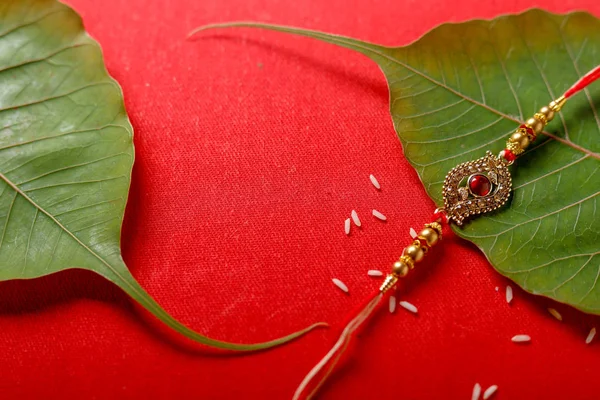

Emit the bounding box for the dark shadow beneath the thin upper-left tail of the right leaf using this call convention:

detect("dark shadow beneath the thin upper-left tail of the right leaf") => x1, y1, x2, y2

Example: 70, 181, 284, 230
193, 33, 389, 103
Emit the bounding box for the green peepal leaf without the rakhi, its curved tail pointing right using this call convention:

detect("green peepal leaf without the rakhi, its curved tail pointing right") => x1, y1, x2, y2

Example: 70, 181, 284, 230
0, 0, 326, 351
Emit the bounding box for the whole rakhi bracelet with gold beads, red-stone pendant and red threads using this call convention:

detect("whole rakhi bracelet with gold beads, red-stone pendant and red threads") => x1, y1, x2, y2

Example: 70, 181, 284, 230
294, 66, 600, 400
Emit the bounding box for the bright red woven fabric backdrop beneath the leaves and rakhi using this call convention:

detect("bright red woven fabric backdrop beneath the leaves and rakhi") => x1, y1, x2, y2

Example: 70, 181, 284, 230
0, 0, 600, 399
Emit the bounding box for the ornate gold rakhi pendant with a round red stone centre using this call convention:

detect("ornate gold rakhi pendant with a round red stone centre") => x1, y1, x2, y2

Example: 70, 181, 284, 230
443, 151, 512, 225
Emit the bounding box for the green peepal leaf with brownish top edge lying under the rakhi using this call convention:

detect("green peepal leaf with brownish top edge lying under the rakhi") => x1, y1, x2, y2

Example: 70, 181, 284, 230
192, 10, 600, 314
